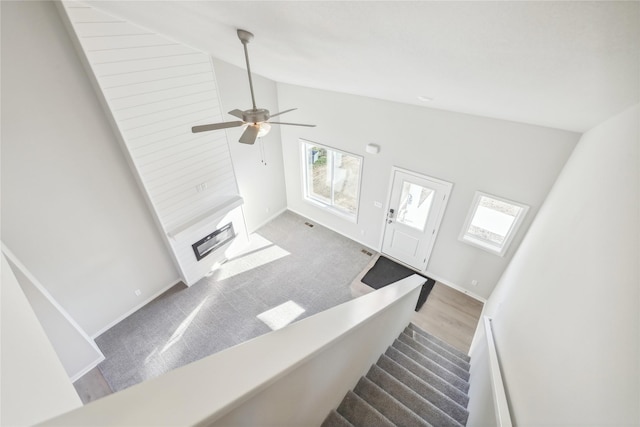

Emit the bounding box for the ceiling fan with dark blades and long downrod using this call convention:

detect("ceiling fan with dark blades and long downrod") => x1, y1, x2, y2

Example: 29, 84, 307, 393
191, 30, 315, 144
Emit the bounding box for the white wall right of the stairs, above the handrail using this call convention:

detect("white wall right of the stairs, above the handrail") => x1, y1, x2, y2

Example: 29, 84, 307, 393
470, 105, 640, 426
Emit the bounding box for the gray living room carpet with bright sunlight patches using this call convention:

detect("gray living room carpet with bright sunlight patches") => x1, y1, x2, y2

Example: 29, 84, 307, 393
96, 211, 373, 392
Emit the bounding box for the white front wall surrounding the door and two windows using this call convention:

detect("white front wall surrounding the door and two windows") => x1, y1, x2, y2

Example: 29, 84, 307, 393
278, 84, 579, 298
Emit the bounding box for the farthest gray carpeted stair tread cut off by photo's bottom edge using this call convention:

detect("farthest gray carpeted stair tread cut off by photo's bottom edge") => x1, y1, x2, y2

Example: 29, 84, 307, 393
366, 365, 460, 427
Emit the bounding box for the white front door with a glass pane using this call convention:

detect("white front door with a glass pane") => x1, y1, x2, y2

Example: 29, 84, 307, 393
382, 168, 453, 271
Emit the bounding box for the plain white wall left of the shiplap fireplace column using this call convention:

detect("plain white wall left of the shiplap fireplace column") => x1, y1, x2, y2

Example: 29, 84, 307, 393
1, 2, 178, 335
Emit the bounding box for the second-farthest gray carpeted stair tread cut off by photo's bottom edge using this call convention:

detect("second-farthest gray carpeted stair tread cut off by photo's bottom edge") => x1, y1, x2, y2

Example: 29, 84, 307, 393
353, 377, 430, 427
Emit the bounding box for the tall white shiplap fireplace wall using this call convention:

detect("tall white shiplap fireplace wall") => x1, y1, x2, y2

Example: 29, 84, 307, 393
63, 2, 246, 285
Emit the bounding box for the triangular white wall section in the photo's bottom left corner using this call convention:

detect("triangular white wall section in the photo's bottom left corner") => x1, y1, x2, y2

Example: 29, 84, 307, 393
0, 256, 82, 426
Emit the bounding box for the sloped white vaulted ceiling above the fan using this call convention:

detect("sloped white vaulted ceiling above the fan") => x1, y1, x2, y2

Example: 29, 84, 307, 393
86, 1, 640, 132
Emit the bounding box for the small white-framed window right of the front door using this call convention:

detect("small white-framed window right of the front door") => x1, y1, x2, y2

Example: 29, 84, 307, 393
460, 191, 529, 256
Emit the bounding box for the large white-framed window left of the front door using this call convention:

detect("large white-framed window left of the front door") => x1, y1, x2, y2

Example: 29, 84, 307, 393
300, 141, 362, 222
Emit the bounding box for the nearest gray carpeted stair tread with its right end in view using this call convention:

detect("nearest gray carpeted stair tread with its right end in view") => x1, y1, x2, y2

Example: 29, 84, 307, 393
376, 354, 469, 425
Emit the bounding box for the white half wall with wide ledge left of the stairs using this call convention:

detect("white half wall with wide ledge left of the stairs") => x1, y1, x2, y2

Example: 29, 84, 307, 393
42, 275, 425, 427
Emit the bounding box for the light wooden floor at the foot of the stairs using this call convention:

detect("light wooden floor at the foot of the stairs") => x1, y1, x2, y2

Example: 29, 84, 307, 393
411, 282, 483, 353
